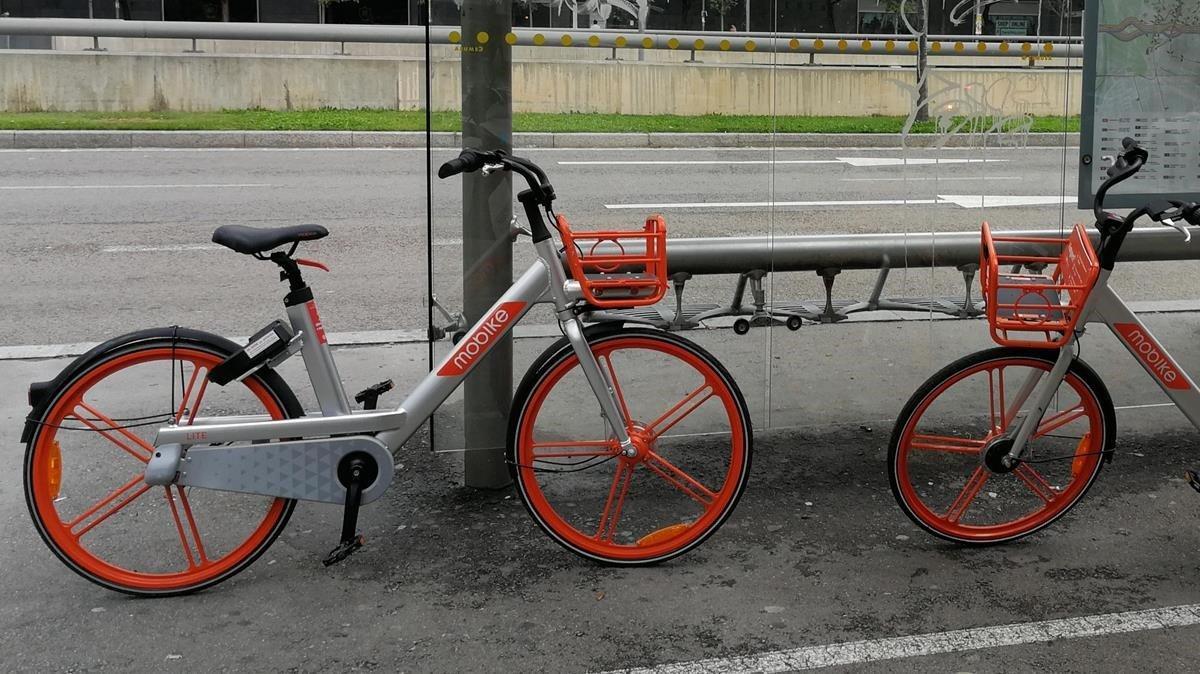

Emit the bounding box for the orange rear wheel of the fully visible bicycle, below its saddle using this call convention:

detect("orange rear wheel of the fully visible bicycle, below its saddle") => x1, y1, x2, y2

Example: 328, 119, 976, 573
25, 332, 301, 595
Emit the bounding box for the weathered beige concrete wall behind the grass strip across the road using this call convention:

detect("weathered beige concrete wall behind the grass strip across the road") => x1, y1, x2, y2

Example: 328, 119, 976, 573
0, 52, 1080, 115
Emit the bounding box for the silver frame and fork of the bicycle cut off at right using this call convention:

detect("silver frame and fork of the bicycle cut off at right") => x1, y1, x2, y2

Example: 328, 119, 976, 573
1006, 269, 1200, 459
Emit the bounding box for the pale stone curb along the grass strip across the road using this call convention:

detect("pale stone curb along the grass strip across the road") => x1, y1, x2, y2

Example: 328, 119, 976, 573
0, 131, 1079, 150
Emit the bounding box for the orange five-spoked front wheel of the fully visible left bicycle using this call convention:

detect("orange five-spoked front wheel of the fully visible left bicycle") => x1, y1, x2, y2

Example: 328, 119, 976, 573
509, 329, 751, 565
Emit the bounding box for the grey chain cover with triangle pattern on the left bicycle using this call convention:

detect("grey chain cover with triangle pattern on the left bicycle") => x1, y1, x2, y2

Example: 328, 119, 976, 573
145, 435, 395, 505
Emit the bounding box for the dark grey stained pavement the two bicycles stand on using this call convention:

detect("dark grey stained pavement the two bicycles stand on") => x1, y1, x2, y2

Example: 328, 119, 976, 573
0, 313, 1200, 672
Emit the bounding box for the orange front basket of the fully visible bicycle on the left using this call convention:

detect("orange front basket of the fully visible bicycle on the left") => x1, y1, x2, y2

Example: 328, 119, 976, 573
558, 216, 667, 308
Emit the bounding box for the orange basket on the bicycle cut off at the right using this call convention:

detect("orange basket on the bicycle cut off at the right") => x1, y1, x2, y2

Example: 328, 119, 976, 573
979, 222, 1100, 349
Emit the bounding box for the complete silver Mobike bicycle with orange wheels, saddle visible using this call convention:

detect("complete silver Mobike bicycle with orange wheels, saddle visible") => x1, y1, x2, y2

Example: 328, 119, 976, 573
22, 150, 752, 595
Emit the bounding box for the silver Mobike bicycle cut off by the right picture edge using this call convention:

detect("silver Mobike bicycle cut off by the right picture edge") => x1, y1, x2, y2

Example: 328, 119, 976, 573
888, 138, 1200, 543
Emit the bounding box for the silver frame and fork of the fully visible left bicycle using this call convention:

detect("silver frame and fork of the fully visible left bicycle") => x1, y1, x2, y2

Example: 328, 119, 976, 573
155, 233, 634, 453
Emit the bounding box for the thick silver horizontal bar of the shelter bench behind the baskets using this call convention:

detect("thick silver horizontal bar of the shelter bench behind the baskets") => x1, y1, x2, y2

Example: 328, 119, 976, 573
667, 228, 1200, 275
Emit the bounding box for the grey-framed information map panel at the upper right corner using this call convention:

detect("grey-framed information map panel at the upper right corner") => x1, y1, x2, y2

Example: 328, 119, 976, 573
1079, 0, 1200, 209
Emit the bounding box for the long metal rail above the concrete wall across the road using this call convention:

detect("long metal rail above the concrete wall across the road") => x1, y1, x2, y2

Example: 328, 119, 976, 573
0, 17, 1084, 58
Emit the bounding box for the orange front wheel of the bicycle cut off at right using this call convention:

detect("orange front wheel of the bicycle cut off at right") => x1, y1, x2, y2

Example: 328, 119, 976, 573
888, 348, 1116, 544
